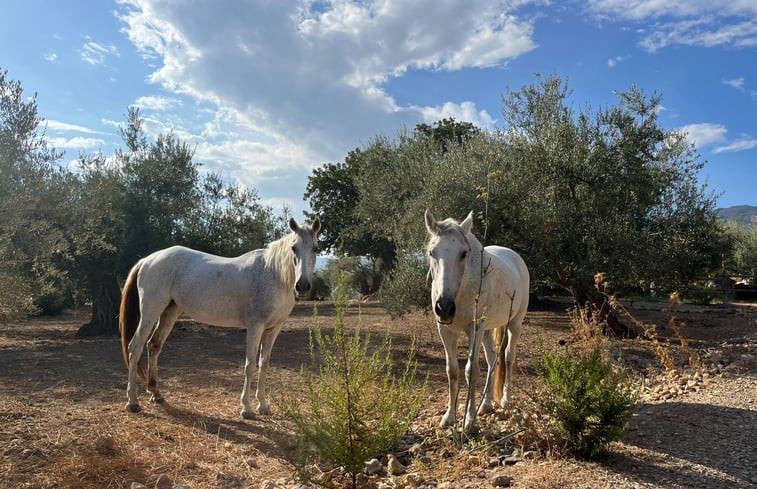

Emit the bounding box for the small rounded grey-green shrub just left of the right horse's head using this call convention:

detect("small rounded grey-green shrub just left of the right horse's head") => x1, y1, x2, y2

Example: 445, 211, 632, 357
381, 255, 430, 318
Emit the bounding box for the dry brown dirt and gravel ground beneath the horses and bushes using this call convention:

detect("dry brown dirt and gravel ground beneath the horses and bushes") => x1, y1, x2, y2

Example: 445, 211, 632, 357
0, 301, 757, 489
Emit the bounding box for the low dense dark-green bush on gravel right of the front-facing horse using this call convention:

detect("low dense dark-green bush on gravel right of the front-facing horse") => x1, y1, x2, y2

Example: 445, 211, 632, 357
536, 343, 634, 458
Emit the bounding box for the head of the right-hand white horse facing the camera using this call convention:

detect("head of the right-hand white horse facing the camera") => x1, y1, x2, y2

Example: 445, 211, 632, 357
425, 210, 473, 324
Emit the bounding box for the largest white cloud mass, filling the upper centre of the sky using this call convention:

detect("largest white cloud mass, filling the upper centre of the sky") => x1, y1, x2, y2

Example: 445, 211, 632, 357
121, 0, 542, 196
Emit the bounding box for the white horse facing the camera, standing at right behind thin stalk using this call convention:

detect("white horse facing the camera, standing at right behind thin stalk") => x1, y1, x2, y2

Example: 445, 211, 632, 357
425, 210, 530, 430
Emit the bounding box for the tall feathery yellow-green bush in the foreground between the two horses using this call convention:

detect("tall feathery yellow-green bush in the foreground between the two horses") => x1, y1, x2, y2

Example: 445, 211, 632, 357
281, 274, 425, 484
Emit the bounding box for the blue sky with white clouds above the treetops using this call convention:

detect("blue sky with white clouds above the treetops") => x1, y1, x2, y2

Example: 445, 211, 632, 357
0, 0, 757, 217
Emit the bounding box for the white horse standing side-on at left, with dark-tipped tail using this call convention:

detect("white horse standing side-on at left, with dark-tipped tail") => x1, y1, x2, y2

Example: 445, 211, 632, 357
119, 218, 321, 419
